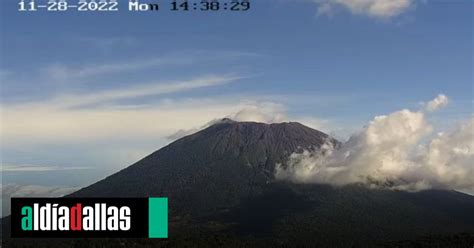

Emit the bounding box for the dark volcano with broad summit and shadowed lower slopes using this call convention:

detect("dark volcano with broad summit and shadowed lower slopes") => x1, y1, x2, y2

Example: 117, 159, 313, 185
3, 119, 474, 247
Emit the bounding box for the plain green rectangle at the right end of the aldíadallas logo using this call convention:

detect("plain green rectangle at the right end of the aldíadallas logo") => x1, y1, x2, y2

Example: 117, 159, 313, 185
148, 198, 168, 238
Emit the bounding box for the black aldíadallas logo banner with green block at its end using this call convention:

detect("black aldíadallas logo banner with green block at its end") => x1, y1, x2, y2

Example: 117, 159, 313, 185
11, 198, 168, 238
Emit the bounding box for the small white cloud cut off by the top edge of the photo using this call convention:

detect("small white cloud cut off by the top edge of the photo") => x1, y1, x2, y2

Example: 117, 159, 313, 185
314, 0, 415, 18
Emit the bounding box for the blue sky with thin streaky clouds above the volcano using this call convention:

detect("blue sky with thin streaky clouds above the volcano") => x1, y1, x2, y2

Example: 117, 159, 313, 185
0, 0, 474, 211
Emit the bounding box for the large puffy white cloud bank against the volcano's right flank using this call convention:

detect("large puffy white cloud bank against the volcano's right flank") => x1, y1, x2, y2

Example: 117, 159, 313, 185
276, 95, 474, 191
